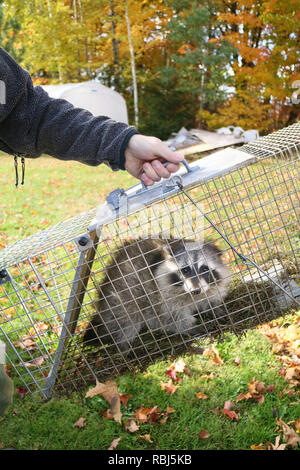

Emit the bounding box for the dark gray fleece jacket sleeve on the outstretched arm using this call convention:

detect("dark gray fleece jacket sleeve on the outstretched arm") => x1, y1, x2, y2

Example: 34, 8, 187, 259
0, 48, 138, 170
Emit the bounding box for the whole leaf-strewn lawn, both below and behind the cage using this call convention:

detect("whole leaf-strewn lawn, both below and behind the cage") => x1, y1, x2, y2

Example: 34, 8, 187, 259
0, 152, 300, 450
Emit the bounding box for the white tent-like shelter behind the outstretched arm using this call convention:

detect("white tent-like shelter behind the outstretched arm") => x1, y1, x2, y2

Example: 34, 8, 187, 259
43, 80, 128, 124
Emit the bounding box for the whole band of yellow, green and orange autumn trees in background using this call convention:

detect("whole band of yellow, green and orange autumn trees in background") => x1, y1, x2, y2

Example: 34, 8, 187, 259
0, 0, 300, 133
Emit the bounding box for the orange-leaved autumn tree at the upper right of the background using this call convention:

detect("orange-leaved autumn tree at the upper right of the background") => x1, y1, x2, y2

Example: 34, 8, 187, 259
202, 0, 300, 133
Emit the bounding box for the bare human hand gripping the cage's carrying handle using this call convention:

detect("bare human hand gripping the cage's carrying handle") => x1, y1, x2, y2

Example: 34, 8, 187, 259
125, 134, 184, 186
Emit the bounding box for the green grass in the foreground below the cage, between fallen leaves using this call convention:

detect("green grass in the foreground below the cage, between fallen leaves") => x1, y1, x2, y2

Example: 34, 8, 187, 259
0, 324, 300, 450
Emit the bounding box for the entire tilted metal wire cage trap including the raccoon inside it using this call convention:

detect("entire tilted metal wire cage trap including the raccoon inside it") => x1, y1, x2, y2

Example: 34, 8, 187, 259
0, 123, 300, 398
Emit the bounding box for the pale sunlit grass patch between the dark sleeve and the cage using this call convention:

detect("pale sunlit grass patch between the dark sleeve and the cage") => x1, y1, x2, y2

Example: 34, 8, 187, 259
0, 155, 137, 244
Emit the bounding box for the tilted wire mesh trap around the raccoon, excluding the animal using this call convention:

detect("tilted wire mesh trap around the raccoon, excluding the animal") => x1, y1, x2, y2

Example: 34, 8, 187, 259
0, 123, 300, 398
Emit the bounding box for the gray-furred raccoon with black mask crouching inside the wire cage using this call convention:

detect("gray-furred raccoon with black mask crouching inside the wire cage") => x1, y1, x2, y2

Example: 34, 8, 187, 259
83, 238, 230, 352
